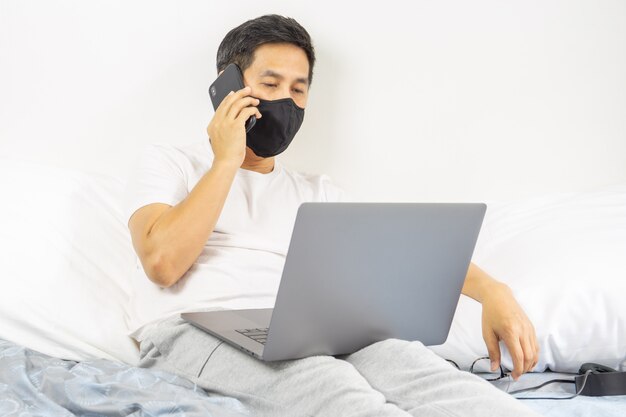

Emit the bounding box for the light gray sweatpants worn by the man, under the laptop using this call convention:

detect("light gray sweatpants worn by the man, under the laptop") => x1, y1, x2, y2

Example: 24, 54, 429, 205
139, 316, 538, 417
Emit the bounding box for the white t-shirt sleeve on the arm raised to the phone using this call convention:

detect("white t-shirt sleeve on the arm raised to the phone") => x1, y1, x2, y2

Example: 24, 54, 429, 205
124, 145, 189, 226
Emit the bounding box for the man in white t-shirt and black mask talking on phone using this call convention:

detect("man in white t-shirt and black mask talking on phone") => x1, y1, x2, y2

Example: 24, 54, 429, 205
128, 15, 538, 416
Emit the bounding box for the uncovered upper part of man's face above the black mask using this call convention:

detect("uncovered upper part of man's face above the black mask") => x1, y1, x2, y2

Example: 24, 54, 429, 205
243, 43, 309, 108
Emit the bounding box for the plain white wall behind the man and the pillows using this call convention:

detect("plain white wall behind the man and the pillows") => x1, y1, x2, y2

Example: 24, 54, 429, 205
0, 0, 626, 201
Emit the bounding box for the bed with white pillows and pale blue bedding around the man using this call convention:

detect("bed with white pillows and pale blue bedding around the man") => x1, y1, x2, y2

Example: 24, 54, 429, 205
0, 158, 626, 416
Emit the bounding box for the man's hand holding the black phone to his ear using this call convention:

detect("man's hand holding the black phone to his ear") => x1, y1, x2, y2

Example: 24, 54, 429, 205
207, 87, 261, 167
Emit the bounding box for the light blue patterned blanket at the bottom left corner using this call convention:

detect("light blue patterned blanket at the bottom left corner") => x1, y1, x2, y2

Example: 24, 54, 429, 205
0, 339, 250, 417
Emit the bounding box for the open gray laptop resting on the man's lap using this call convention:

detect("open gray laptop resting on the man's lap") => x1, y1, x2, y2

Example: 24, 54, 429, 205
182, 203, 486, 361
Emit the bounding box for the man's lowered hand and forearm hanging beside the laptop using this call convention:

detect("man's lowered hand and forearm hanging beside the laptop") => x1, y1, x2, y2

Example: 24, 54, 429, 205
463, 263, 539, 380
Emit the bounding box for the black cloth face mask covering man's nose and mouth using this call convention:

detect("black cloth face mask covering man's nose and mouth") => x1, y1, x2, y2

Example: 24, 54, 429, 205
246, 98, 304, 158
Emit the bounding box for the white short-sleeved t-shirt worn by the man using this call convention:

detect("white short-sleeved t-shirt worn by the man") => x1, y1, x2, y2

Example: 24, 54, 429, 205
125, 139, 347, 340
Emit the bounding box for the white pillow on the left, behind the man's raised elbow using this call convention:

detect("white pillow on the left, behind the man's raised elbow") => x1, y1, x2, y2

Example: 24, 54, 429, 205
0, 158, 138, 364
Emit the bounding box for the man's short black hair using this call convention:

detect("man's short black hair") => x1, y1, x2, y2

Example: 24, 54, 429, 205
217, 14, 315, 85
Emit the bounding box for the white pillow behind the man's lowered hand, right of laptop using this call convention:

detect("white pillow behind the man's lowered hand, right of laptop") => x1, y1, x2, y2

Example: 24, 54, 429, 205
432, 186, 626, 372
